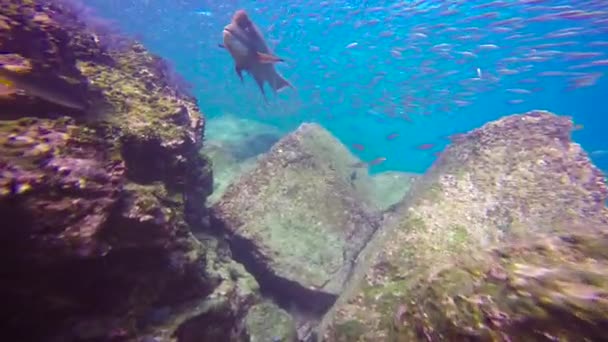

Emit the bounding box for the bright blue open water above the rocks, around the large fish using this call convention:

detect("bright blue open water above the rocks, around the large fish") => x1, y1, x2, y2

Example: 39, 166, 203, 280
86, 0, 608, 172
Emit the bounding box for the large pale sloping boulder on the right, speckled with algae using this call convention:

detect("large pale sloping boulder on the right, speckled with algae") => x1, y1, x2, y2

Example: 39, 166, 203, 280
320, 111, 608, 341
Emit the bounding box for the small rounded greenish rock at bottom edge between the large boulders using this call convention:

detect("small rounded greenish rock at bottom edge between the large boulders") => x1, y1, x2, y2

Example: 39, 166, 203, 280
245, 302, 298, 342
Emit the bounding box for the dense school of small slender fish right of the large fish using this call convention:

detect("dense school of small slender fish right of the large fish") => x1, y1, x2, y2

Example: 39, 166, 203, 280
256, 0, 608, 165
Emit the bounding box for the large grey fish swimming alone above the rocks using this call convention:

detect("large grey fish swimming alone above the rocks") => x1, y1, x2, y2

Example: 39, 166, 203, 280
223, 10, 293, 99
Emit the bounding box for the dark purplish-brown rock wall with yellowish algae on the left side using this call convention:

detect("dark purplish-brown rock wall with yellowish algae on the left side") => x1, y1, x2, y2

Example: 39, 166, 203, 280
0, 0, 252, 341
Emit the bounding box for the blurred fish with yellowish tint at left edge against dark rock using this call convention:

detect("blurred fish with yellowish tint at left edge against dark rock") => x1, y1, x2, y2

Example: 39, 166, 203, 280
0, 67, 87, 111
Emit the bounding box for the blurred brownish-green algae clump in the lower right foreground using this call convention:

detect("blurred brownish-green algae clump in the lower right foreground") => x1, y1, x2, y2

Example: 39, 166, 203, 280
384, 231, 608, 340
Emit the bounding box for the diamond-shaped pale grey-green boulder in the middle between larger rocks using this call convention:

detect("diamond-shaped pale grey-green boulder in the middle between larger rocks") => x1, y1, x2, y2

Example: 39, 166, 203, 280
213, 124, 379, 312
